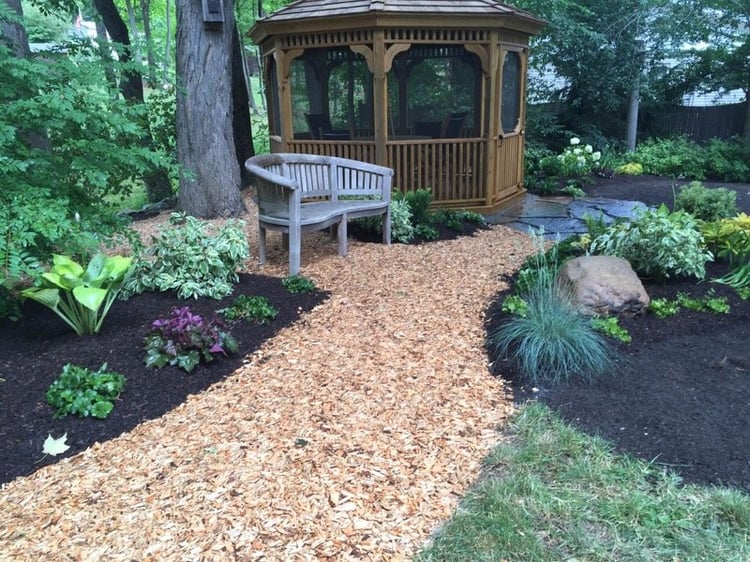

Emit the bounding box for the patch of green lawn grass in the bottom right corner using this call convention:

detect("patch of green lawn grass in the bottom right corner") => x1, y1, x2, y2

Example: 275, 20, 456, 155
416, 404, 750, 562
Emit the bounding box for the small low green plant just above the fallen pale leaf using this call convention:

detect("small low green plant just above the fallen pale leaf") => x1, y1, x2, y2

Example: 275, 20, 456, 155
45, 363, 125, 419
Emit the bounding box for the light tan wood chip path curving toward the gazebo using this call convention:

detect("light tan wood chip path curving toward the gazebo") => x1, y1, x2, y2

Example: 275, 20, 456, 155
0, 203, 531, 562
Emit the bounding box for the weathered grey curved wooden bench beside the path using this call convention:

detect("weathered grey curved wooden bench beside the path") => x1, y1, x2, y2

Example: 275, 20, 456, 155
245, 153, 393, 275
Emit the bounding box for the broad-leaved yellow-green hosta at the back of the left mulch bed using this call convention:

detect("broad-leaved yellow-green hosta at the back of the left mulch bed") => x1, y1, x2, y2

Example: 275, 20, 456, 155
21, 254, 132, 336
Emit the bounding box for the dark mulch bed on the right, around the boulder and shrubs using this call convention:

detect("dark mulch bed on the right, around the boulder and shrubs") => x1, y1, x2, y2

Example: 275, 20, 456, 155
488, 176, 750, 491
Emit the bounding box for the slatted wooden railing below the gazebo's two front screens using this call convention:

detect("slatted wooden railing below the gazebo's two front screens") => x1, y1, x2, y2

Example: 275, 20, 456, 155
289, 138, 487, 207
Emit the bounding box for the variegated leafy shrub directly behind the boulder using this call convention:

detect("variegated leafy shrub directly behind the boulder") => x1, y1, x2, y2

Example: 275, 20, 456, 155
589, 205, 713, 279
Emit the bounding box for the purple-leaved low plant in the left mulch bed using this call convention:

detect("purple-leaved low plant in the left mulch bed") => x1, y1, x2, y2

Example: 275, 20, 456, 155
144, 306, 239, 373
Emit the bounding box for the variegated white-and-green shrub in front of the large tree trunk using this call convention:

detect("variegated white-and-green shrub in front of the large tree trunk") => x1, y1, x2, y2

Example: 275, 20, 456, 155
126, 213, 250, 299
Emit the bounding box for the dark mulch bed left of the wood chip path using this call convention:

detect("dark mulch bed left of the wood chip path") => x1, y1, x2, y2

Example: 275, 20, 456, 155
0, 275, 327, 483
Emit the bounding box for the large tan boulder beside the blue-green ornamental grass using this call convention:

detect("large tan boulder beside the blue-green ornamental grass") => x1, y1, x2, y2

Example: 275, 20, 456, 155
557, 256, 650, 316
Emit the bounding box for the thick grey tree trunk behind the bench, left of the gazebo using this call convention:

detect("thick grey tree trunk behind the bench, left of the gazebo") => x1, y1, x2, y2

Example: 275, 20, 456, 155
176, 0, 245, 218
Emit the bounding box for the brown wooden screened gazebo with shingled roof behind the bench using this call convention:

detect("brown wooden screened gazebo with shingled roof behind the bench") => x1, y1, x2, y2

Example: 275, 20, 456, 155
250, 0, 542, 212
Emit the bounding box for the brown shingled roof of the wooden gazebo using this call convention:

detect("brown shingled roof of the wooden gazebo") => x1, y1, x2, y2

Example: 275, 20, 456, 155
258, 0, 531, 22
